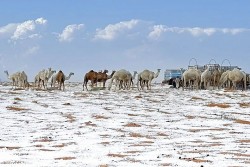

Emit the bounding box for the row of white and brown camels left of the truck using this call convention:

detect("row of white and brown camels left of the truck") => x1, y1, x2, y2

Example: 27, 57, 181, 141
4, 68, 160, 90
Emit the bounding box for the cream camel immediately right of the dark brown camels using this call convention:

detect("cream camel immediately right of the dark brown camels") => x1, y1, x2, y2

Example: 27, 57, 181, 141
108, 69, 132, 90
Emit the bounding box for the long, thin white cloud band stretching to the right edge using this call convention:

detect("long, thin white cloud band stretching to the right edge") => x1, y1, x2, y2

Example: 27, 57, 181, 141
148, 25, 250, 39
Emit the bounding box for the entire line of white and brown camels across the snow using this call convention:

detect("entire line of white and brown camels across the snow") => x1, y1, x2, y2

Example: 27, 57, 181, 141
4, 67, 249, 90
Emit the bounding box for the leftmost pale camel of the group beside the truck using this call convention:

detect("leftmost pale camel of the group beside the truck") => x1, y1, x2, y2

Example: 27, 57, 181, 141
182, 68, 201, 90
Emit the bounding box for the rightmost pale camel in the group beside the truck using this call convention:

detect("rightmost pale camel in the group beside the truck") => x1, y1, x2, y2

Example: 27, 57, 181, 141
222, 68, 247, 90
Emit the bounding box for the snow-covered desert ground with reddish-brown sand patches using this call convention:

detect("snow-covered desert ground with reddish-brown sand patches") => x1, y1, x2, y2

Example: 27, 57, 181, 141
0, 83, 250, 167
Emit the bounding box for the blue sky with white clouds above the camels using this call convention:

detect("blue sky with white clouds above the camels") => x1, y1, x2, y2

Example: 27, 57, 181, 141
0, 0, 250, 81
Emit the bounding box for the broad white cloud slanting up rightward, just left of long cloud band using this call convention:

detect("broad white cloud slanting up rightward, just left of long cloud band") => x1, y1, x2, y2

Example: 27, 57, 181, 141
94, 19, 139, 40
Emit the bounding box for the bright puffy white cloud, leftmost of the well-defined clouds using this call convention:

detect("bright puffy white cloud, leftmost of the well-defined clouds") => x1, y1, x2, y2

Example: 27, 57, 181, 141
11, 18, 47, 40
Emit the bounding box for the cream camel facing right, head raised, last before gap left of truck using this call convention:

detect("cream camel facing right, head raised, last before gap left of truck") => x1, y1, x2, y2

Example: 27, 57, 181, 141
137, 69, 161, 90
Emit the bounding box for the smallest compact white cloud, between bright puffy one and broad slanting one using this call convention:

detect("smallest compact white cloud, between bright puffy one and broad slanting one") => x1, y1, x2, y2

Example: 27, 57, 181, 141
58, 24, 84, 42
